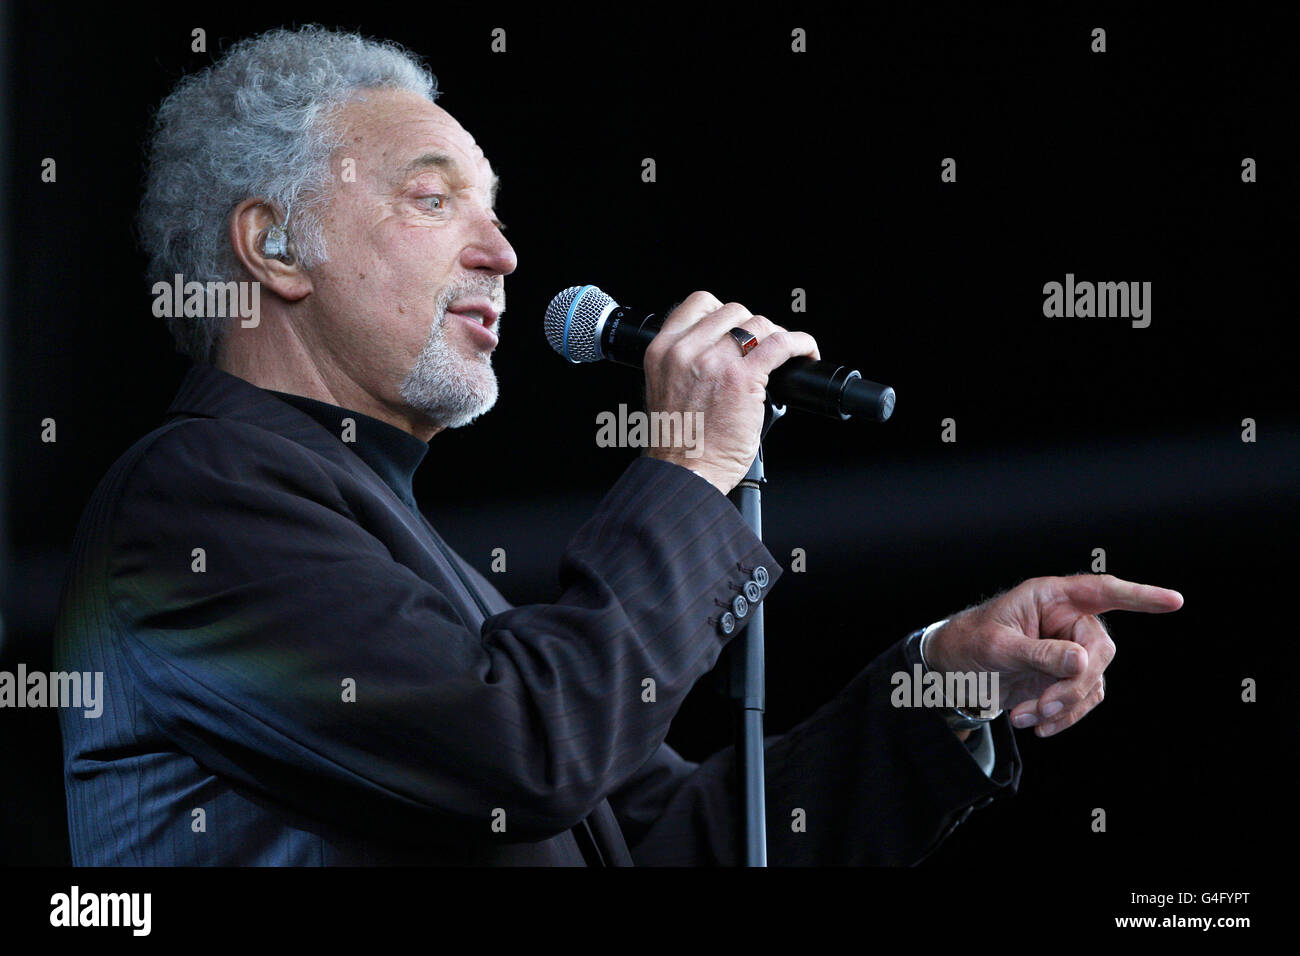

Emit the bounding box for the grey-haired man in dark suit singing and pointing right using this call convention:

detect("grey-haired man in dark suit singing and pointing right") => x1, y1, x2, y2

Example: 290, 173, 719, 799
57, 27, 1182, 865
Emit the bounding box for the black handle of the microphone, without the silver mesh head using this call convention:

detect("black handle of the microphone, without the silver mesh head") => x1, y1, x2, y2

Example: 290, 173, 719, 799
601, 306, 894, 421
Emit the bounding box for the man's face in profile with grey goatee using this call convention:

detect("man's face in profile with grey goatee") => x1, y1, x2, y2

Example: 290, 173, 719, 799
300, 90, 517, 432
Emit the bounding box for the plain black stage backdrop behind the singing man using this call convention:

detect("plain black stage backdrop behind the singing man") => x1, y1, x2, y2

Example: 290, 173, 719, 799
0, 3, 1300, 926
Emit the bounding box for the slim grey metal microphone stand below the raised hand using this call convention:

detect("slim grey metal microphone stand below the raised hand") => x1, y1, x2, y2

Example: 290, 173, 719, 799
727, 397, 785, 866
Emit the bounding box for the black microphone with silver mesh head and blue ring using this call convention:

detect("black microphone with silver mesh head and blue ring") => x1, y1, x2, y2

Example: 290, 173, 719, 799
546, 285, 894, 421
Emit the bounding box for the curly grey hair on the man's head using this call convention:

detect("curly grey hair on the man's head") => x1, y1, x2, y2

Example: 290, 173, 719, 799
138, 25, 438, 364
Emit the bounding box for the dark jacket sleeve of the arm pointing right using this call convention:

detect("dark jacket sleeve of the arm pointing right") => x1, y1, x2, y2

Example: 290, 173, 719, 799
610, 641, 1021, 866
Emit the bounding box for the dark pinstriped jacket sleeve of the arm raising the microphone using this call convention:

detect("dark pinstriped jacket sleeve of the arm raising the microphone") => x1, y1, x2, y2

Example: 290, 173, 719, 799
104, 419, 780, 843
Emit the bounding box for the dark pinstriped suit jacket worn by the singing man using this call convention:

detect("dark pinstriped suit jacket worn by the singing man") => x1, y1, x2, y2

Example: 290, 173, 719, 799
56, 365, 1019, 865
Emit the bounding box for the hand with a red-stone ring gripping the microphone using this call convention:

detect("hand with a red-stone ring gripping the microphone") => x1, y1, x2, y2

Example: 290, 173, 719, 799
642, 291, 822, 494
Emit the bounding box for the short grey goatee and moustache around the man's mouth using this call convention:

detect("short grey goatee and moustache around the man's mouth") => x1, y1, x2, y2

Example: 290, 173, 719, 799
400, 280, 504, 428
